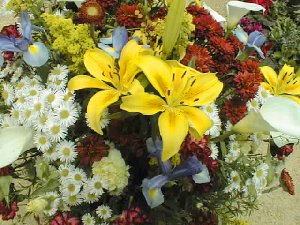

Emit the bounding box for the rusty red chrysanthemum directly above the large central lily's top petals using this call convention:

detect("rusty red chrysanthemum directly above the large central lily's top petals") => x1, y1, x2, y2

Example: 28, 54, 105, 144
181, 45, 214, 73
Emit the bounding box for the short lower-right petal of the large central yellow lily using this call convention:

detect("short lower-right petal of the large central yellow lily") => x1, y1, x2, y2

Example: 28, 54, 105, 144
178, 106, 213, 139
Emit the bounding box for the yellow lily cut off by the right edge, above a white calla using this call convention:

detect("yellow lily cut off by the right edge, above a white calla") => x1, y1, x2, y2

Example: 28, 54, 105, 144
260, 65, 300, 103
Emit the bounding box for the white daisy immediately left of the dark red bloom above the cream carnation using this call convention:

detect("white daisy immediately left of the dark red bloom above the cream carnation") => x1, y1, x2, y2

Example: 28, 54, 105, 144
56, 140, 77, 163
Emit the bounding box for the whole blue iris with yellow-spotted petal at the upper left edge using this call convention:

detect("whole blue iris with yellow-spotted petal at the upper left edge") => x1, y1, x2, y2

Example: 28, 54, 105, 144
0, 12, 49, 67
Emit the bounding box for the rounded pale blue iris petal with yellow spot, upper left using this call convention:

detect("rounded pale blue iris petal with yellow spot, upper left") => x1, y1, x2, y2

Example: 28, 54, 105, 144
23, 42, 49, 67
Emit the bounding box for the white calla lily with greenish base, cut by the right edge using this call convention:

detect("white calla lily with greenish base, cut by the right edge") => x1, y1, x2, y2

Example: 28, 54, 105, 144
232, 97, 300, 138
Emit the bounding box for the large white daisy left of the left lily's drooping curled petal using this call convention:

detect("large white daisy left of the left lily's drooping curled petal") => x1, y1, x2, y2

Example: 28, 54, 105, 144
54, 102, 78, 127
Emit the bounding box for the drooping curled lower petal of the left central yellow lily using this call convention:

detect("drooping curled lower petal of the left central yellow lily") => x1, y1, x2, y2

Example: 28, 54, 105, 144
87, 90, 120, 135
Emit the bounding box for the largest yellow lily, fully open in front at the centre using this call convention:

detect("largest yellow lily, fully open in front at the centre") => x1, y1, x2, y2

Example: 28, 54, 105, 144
120, 55, 223, 161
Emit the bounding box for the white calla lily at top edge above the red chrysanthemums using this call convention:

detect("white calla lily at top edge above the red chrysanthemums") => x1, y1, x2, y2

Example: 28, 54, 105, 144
203, 1, 266, 30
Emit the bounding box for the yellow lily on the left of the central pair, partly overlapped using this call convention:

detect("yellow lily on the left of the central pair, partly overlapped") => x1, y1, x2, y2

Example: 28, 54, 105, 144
68, 40, 150, 134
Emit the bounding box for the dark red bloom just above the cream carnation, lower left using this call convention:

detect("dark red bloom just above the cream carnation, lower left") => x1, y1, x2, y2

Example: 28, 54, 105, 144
77, 134, 109, 166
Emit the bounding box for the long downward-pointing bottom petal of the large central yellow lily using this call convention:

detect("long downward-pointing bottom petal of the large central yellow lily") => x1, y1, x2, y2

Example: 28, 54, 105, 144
158, 109, 189, 161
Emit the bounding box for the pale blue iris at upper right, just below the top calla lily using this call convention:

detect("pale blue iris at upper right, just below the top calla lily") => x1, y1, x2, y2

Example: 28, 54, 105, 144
234, 27, 267, 59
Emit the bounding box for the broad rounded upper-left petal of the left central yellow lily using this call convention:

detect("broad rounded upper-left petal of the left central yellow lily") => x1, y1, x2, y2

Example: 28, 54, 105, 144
84, 49, 114, 82
